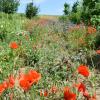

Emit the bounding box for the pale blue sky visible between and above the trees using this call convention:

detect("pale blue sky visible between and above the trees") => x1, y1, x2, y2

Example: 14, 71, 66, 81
18, 0, 77, 15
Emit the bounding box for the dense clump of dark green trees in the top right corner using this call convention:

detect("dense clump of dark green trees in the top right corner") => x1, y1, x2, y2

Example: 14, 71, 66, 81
63, 0, 100, 24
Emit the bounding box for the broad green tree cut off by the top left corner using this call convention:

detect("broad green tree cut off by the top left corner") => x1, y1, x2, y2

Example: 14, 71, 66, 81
0, 0, 19, 14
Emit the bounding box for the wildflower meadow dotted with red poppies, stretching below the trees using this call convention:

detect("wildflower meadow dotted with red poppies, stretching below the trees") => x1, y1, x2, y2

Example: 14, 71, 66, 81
0, 14, 100, 100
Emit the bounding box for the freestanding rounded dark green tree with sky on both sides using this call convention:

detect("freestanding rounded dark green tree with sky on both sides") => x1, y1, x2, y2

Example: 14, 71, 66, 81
26, 3, 38, 19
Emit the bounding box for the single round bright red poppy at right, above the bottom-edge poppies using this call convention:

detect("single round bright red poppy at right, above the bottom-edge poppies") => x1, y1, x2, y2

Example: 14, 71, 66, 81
77, 65, 89, 77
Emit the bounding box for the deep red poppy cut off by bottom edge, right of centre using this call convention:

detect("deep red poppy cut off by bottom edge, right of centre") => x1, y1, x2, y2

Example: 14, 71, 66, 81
64, 87, 76, 100
